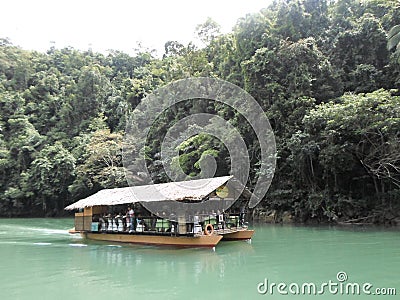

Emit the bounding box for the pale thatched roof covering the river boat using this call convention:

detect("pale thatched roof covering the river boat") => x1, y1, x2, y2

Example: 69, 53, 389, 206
65, 176, 233, 210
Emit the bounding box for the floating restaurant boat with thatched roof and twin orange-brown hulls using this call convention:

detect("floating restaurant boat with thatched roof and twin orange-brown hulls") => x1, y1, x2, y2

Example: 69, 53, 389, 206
65, 176, 254, 248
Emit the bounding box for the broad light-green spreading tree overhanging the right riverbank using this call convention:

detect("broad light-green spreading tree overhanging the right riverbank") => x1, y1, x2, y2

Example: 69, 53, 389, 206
296, 90, 400, 218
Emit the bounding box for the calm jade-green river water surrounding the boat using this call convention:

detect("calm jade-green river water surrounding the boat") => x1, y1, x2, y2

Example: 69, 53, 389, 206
0, 219, 400, 300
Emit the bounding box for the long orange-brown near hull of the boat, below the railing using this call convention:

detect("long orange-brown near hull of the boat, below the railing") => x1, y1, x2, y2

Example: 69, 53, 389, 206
81, 232, 222, 248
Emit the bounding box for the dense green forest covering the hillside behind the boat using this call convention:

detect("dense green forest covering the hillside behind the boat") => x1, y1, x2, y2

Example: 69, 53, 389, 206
0, 0, 400, 224
